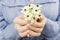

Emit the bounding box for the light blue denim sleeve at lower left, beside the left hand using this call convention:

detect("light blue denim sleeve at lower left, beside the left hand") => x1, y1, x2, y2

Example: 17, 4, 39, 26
3, 23, 20, 40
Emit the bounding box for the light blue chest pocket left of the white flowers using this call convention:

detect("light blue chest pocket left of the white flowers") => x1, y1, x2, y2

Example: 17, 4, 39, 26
1, 4, 24, 23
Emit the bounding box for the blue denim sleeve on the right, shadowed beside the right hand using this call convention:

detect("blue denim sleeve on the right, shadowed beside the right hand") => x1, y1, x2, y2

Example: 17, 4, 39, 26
42, 14, 60, 37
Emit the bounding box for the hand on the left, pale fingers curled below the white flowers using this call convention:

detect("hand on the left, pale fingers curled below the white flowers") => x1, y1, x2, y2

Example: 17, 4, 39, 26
14, 16, 30, 37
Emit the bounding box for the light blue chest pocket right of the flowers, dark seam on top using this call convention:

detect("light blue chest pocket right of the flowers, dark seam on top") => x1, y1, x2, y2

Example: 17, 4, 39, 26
36, 0, 59, 20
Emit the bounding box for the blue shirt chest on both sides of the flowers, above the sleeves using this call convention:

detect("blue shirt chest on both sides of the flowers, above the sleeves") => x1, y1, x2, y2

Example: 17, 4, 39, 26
1, 0, 59, 23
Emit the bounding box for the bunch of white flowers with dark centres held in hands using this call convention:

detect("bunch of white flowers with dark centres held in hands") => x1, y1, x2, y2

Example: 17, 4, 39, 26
22, 4, 42, 22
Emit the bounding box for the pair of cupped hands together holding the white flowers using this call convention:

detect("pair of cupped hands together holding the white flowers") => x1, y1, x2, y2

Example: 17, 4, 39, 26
14, 15, 46, 37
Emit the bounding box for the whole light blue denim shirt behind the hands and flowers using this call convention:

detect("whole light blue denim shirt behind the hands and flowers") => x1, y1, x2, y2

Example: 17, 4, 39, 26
0, 0, 60, 40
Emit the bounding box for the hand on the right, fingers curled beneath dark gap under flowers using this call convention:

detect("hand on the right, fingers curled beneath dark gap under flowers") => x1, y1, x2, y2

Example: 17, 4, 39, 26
28, 15, 46, 37
